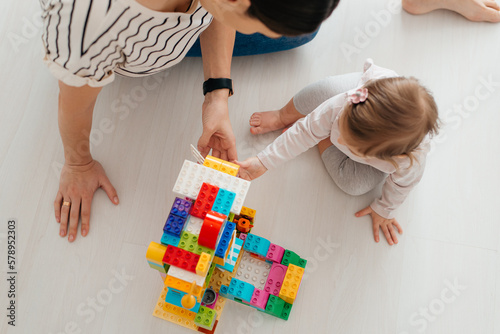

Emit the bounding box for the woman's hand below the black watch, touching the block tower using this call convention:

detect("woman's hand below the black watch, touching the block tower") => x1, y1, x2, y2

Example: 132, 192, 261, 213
198, 89, 238, 161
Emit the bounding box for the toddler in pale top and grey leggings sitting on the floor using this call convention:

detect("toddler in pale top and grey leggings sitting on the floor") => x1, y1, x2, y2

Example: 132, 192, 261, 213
238, 59, 438, 245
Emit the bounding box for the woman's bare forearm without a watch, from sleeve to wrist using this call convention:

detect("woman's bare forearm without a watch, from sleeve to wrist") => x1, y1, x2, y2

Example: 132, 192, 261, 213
58, 82, 101, 165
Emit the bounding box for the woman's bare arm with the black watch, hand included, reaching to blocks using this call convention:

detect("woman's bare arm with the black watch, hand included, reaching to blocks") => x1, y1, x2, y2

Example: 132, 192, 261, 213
198, 19, 238, 161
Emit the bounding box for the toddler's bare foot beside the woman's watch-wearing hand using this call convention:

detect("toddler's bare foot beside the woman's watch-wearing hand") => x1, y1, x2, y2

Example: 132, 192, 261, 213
250, 99, 304, 135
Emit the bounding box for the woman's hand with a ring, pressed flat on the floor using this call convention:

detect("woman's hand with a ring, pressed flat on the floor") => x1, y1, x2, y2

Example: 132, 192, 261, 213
54, 160, 118, 242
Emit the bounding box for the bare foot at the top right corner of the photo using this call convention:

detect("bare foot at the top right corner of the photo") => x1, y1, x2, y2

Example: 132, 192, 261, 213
403, 0, 500, 22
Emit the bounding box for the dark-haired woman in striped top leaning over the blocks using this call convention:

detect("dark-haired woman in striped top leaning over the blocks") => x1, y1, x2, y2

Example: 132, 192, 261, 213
41, 0, 339, 242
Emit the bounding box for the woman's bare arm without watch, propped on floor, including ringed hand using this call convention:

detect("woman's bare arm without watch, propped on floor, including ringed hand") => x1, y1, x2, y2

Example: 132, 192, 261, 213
54, 81, 118, 242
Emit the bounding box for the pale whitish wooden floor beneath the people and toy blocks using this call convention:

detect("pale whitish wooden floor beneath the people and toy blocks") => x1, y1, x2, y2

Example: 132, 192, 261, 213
0, 0, 500, 334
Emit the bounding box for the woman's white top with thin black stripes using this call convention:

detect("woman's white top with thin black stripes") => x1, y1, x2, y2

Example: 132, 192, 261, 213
40, 0, 212, 87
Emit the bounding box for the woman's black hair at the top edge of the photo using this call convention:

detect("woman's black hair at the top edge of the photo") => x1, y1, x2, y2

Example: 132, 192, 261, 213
248, 0, 340, 36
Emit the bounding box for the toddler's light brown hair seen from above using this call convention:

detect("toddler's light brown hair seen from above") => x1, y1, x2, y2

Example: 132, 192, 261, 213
339, 77, 439, 168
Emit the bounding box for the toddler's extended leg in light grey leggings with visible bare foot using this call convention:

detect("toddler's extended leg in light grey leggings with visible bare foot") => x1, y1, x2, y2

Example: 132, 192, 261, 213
250, 73, 362, 134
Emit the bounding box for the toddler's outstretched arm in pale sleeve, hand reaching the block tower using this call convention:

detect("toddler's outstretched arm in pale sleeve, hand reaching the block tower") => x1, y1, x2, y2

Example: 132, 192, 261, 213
237, 94, 345, 180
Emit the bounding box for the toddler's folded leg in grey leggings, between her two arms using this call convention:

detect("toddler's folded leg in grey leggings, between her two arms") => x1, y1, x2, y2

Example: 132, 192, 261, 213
320, 143, 387, 196
